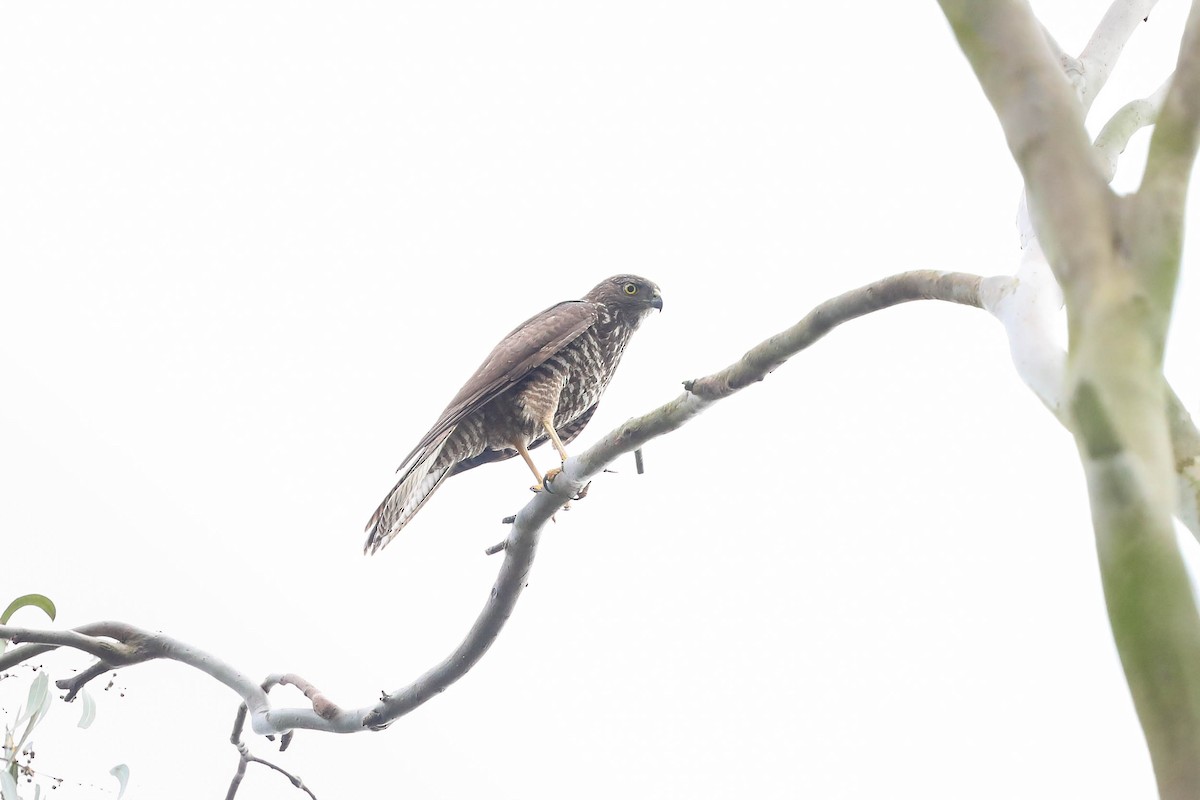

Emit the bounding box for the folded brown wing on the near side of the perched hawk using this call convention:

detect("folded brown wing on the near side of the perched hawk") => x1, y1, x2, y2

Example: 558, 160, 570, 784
396, 300, 599, 473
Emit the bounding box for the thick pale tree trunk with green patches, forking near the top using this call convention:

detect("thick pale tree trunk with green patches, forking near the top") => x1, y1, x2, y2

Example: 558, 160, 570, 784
941, 0, 1200, 798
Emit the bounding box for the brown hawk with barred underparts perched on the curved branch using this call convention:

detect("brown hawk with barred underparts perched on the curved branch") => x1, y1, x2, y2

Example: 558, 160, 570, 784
364, 275, 662, 553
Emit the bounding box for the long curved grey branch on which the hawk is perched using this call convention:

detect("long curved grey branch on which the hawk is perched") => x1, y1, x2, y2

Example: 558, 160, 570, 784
0, 270, 1200, 758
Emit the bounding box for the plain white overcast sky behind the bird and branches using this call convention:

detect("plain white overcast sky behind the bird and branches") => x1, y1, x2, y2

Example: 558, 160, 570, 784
0, 0, 1200, 800
